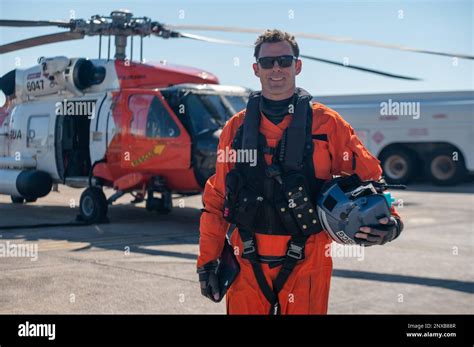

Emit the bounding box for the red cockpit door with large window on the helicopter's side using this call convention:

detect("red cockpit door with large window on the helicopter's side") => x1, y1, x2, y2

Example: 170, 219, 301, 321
123, 90, 191, 171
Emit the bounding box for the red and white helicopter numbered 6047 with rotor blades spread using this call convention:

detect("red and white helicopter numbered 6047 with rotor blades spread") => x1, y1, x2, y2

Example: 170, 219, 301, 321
0, 10, 474, 223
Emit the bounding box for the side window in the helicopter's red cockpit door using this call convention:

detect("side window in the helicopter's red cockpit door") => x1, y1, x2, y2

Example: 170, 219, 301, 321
129, 95, 180, 138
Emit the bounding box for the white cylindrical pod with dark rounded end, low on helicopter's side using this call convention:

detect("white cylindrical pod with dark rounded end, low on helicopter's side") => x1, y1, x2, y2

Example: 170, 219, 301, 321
0, 169, 53, 199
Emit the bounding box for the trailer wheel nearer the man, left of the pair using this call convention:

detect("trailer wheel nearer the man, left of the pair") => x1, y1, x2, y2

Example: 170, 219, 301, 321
380, 148, 416, 184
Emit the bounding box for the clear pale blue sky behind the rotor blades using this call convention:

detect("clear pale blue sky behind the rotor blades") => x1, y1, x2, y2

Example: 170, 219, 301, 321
0, 0, 474, 100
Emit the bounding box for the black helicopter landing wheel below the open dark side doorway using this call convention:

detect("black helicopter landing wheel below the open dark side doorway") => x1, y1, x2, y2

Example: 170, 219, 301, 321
79, 187, 108, 223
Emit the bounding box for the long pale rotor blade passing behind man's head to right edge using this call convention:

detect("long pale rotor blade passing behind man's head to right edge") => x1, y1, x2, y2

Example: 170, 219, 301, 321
167, 25, 474, 60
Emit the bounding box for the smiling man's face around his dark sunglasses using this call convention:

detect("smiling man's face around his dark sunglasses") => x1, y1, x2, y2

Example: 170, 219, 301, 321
253, 41, 302, 100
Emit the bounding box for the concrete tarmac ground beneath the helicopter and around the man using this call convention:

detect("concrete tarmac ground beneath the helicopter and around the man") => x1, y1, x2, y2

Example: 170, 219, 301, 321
0, 183, 474, 314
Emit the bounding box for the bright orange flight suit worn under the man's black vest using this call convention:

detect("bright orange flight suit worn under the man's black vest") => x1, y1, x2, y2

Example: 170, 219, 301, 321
197, 103, 399, 314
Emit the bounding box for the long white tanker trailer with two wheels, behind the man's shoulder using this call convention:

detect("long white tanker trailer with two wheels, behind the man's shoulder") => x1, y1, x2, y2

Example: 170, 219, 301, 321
313, 91, 474, 185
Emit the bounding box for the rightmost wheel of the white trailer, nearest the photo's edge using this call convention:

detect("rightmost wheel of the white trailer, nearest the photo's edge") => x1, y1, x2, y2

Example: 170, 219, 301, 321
425, 149, 467, 186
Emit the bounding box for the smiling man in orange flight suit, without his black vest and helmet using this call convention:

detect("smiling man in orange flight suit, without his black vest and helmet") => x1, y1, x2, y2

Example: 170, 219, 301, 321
197, 30, 403, 314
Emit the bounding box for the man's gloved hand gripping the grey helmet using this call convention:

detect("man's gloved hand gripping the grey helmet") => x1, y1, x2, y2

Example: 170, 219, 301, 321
355, 217, 403, 246
